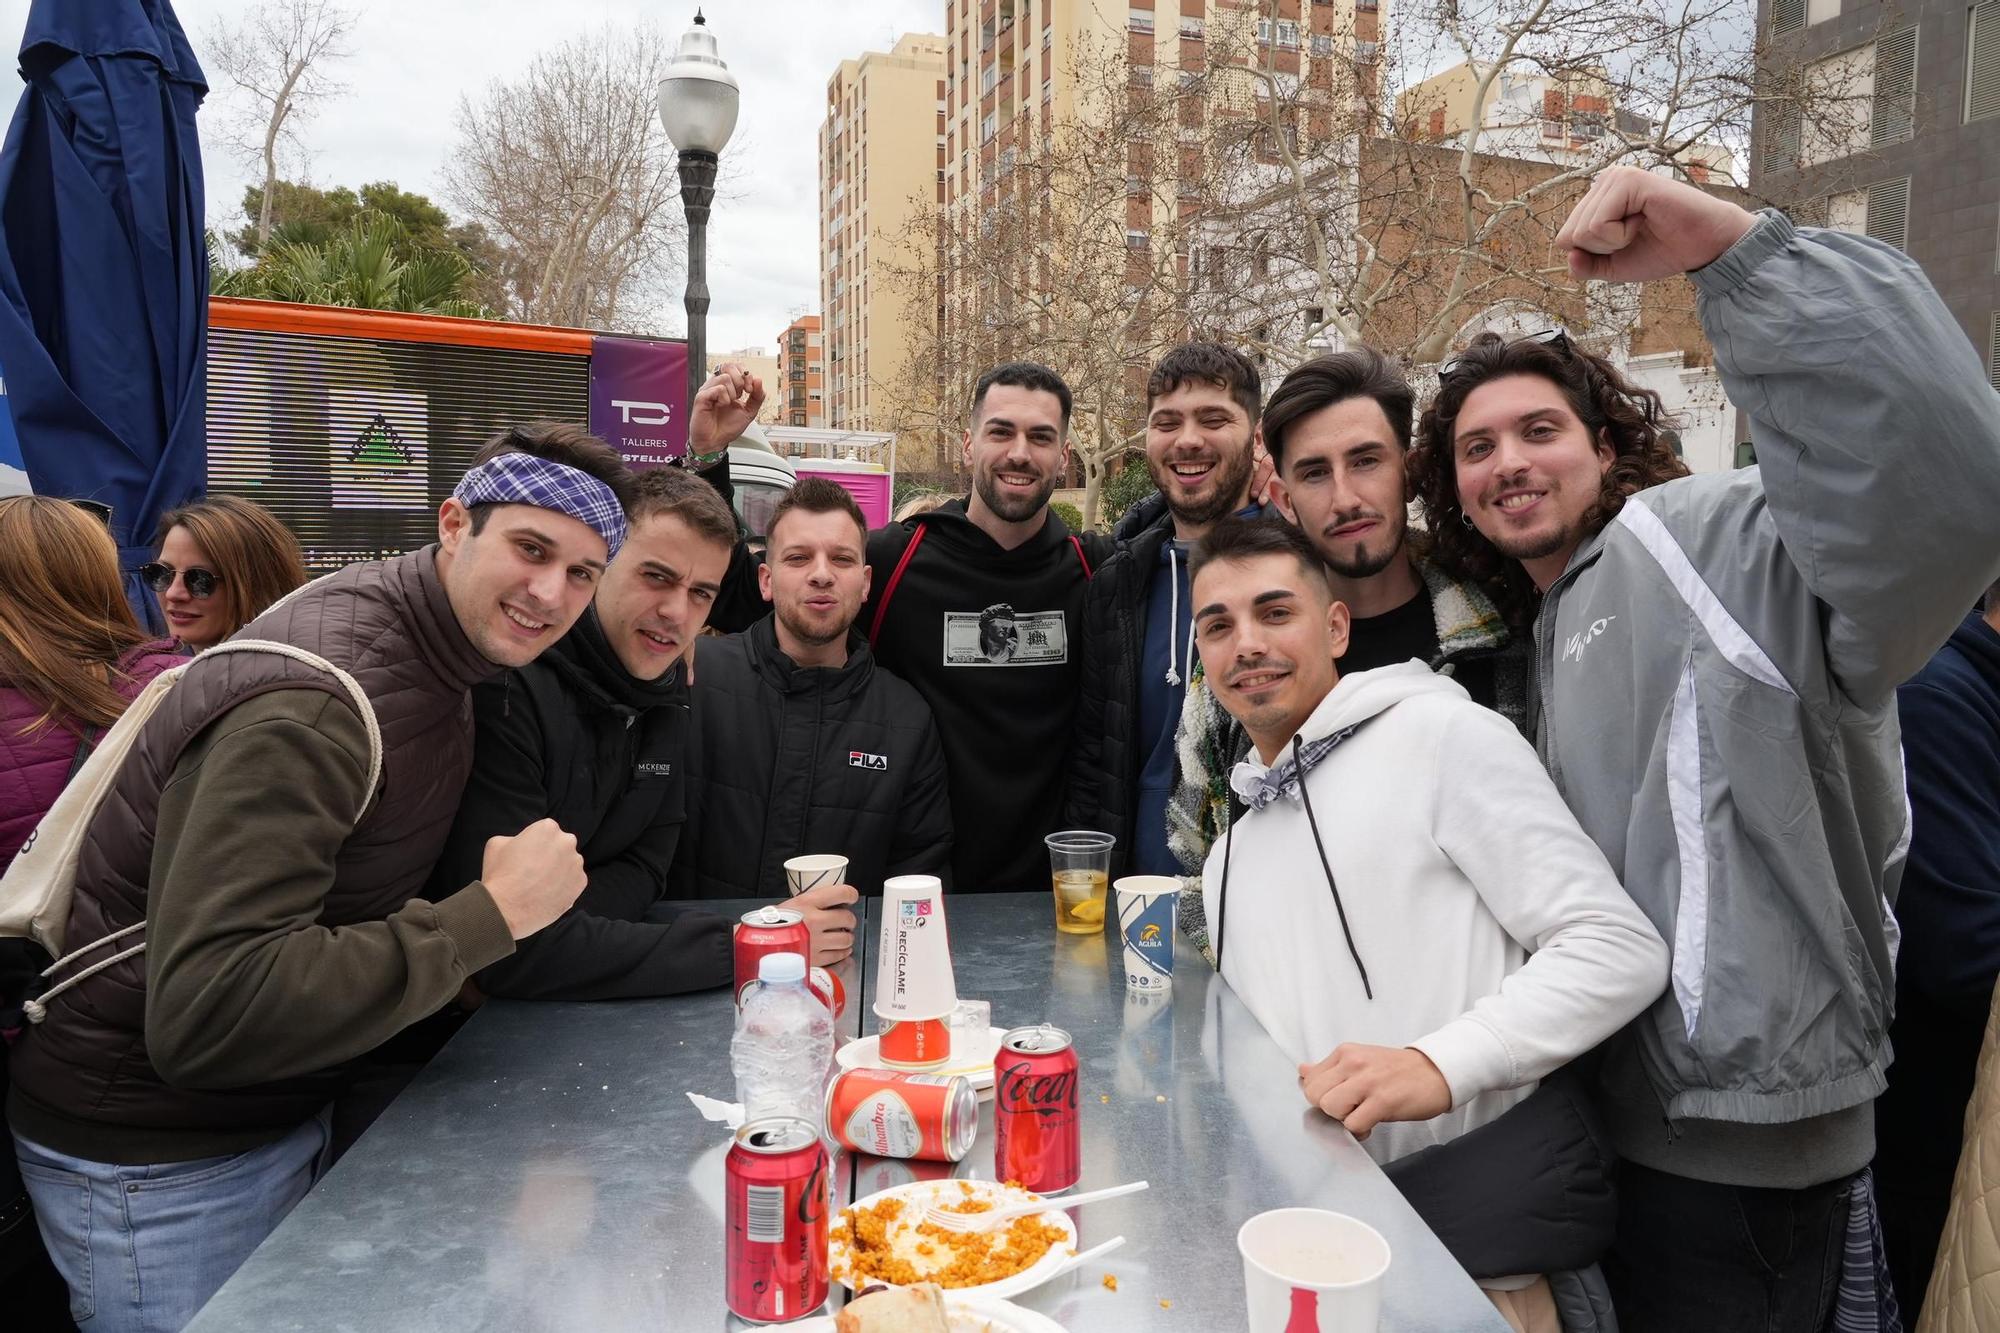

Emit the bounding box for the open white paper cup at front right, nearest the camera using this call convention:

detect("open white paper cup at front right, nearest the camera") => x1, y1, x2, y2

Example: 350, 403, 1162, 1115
1236, 1209, 1390, 1333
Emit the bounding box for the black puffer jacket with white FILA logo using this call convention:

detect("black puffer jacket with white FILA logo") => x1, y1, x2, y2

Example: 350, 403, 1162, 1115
674, 616, 952, 899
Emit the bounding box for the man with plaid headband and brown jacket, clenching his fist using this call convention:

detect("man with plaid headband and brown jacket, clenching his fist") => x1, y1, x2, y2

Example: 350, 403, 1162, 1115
8, 422, 632, 1331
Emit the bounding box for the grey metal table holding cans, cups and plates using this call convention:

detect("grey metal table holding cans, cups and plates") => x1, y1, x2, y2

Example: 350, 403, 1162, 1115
190, 895, 1506, 1333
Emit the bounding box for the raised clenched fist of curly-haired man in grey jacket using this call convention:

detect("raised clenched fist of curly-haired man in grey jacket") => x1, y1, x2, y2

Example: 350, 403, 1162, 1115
1556, 166, 1756, 282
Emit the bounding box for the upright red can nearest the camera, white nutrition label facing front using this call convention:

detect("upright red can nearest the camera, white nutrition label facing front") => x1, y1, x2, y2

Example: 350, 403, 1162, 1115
722, 1115, 828, 1323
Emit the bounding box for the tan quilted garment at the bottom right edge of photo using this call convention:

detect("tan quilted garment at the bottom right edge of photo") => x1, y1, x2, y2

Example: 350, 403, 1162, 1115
1916, 987, 2000, 1333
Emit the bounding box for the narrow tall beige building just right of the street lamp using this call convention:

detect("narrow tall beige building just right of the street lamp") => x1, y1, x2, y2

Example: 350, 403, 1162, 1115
820, 32, 944, 430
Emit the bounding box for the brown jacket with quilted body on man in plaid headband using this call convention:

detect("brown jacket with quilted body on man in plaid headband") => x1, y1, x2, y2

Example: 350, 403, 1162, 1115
8, 548, 512, 1163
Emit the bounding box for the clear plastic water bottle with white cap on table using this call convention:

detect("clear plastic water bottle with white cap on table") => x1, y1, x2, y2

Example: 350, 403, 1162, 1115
730, 953, 834, 1125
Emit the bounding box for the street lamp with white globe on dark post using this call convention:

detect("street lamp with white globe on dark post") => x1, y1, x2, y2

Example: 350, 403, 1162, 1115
660, 10, 736, 448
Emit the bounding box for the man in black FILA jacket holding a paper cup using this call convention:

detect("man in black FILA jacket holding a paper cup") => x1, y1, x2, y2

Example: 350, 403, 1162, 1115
674, 476, 952, 899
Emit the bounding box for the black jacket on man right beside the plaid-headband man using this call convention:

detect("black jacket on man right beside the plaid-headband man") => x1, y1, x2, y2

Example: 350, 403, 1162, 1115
436, 606, 734, 1001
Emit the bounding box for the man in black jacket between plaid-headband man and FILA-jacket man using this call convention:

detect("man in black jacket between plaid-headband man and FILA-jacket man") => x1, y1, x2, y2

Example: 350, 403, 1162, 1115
436, 468, 852, 999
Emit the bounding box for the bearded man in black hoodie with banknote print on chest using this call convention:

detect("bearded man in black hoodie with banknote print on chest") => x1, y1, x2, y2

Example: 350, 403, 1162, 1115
860, 360, 1110, 893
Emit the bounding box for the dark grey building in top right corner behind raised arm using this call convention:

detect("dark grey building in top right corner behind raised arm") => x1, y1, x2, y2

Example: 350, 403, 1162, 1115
1750, 0, 2000, 388
